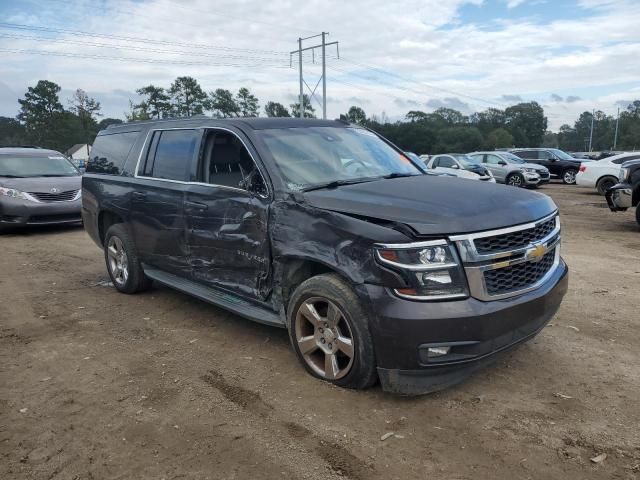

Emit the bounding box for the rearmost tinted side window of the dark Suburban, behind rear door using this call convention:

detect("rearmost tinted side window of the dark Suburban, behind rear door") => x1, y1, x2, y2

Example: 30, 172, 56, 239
87, 132, 139, 175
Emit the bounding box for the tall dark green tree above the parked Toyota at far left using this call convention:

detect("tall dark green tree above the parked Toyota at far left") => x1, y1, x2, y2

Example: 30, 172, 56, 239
17, 80, 64, 146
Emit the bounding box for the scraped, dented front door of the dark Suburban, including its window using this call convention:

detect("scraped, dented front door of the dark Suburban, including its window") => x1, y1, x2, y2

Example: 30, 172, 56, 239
184, 129, 271, 300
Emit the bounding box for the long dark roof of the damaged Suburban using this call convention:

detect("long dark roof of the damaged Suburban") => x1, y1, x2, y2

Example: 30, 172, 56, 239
107, 115, 350, 132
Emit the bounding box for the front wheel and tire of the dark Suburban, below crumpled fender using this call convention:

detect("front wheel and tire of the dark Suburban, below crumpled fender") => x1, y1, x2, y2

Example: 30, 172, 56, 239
287, 274, 378, 389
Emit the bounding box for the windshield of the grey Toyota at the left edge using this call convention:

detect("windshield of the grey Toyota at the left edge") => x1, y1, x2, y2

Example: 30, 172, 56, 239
0, 155, 80, 178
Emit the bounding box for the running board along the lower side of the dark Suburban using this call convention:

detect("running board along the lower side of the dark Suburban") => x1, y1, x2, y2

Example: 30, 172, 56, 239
143, 265, 285, 328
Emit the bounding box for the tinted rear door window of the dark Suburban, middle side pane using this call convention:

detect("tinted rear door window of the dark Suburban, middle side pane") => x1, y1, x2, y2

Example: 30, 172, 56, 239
145, 130, 200, 181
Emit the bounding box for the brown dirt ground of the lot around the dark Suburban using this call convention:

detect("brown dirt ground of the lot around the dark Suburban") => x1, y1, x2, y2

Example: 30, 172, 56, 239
0, 184, 640, 480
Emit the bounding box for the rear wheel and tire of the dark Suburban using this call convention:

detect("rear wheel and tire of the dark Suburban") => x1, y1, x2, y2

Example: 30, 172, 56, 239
104, 223, 152, 293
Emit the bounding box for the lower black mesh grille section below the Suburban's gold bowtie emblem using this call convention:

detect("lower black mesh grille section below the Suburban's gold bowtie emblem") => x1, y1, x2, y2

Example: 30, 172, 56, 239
484, 249, 556, 295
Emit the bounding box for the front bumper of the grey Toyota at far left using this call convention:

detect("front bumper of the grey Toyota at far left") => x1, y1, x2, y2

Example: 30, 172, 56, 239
0, 198, 82, 228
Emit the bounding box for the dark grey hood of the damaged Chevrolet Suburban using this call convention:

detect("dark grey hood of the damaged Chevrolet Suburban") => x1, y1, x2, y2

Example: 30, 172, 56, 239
304, 175, 557, 236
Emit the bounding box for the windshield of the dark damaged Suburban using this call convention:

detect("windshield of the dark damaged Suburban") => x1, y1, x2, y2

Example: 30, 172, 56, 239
256, 127, 422, 190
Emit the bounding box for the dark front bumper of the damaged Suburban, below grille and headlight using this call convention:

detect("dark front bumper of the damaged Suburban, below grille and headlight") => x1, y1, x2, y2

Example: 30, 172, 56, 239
362, 261, 568, 395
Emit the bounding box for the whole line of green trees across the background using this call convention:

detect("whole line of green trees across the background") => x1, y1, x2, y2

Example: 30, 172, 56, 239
0, 76, 640, 154
